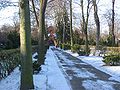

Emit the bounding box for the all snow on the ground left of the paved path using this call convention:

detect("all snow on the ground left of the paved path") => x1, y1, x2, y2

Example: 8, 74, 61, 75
0, 49, 70, 90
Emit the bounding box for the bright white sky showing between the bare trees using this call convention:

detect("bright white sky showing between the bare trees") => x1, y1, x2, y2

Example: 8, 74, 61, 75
0, 0, 120, 33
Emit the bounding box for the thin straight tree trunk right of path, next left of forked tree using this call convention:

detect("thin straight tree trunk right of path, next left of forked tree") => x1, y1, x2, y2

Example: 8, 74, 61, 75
70, 0, 73, 51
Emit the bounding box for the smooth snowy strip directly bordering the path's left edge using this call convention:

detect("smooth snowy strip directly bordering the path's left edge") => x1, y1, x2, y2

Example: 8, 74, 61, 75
46, 49, 70, 90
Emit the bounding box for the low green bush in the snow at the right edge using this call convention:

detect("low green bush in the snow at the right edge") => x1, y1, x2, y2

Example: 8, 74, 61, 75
103, 54, 120, 66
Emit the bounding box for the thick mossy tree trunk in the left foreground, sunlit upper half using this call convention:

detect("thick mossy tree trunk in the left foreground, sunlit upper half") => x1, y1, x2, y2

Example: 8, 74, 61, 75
19, 0, 34, 90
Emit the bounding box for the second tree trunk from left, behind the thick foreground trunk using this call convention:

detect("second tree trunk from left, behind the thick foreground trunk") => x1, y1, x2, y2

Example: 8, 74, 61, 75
38, 0, 47, 65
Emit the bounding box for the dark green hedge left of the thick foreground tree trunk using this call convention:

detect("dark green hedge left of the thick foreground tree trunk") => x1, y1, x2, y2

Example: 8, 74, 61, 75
0, 49, 20, 79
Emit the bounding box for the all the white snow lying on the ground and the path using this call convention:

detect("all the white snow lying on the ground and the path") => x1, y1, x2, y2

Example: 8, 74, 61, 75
0, 47, 120, 90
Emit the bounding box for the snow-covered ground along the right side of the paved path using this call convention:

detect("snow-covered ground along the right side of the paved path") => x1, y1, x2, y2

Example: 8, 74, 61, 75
66, 51, 120, 82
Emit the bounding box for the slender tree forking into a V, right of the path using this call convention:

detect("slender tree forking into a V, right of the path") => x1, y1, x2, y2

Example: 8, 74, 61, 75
81, 0, 90, 55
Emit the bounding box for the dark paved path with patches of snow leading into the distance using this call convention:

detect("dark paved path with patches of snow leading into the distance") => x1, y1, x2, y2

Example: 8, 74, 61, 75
52, 49, 120, 90
